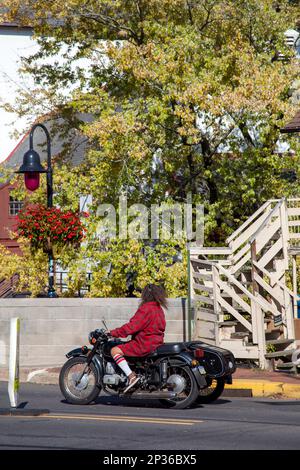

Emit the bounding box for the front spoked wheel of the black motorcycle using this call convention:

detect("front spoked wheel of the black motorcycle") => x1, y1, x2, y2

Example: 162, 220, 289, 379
59, 357, 101, 405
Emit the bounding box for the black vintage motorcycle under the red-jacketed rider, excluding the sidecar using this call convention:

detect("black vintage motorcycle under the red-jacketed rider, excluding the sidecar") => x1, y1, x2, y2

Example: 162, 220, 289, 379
59, 329, 208, 409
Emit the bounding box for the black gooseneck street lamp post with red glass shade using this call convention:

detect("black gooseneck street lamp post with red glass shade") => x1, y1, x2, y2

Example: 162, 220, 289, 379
16, 123, 57, 297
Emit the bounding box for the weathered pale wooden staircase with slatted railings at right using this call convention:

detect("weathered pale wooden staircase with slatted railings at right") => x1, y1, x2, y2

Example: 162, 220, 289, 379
189, 198, 300, 371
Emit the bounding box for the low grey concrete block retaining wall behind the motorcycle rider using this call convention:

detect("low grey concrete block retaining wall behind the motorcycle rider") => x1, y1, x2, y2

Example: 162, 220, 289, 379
0, 298, 188, 369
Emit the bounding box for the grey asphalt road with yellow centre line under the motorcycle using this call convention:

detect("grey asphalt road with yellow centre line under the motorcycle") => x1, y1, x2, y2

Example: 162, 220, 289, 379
0, 382, 300, 450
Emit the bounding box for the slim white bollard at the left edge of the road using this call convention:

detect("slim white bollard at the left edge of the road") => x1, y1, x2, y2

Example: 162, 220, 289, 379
8, 318, 20, 408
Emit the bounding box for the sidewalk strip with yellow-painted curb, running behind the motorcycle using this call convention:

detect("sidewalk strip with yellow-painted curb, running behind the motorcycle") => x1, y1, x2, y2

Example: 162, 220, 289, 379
0, 366, 300, 400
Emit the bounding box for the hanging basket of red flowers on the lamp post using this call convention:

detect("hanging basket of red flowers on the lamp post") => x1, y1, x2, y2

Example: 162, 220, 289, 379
17, 204, 88, 253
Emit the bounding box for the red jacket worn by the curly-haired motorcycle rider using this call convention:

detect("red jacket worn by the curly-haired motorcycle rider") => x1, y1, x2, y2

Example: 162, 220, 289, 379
110, 302, 166, 357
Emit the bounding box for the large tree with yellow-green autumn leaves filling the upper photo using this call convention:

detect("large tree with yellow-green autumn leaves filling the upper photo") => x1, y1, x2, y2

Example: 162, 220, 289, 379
0, 0, 300, 294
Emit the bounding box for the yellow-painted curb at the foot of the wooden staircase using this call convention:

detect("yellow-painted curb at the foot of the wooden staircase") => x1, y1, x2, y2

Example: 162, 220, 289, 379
225, 378, 300, 400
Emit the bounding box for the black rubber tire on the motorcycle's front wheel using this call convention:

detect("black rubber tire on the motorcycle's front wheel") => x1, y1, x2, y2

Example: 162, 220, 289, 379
59, 356, 101, 405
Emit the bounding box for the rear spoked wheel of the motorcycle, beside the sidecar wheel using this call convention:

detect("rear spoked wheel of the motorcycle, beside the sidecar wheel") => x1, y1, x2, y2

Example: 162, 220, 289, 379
160, 362, 198, 409
